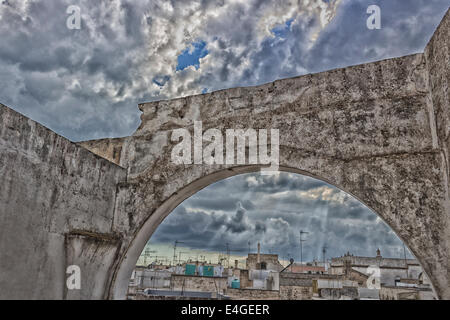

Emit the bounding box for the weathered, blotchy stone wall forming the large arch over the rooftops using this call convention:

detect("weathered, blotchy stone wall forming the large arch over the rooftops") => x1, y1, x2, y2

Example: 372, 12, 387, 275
98, 27, 450, 298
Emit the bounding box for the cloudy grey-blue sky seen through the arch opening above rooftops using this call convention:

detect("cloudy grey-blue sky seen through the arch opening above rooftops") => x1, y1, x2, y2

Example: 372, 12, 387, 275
149, 172, 409, 261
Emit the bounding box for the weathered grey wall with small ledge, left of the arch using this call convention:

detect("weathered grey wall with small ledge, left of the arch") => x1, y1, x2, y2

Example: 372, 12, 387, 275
0, 105, 126, 299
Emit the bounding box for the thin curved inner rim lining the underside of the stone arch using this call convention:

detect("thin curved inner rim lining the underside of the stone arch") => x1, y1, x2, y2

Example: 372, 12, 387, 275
109, 165, 436, 299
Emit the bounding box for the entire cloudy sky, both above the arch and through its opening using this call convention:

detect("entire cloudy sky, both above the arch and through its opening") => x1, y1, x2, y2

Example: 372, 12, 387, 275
0, 0, 449, 266
